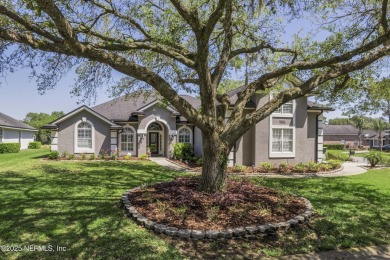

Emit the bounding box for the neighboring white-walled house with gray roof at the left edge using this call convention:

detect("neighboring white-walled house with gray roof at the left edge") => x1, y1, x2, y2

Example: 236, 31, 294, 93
0, 112, 38, 149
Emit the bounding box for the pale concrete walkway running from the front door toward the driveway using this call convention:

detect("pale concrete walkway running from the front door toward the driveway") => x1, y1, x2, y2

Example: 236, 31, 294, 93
149, 157, 367, 178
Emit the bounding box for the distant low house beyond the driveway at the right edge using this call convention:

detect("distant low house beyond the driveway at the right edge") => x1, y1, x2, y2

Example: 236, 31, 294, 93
324, 125, 390, 147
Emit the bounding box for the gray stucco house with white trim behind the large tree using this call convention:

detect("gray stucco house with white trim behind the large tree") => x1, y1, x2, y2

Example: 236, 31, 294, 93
45, 88, 330, 165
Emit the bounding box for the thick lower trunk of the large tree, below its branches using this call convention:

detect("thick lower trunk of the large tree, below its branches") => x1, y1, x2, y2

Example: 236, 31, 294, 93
201, 134, 230, 193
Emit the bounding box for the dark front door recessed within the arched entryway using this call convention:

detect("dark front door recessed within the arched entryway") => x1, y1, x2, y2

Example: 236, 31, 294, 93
146, 121, 166, 156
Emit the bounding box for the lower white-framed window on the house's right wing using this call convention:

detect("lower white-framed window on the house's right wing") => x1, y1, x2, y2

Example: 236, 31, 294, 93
272, 128, 294, 153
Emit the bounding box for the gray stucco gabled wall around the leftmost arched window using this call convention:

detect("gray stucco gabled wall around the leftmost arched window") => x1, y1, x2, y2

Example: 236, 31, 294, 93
58, 110, 111, 155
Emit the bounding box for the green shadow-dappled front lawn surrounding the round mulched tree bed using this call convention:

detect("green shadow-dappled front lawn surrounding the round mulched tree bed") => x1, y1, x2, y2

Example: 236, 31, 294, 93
0, 150, 390, 259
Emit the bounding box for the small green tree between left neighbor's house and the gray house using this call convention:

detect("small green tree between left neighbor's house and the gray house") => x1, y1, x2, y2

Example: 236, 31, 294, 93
22, 111, 64, 144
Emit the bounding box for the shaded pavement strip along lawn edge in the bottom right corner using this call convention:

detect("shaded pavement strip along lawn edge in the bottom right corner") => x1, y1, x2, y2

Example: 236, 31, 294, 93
273, 245, 390, 260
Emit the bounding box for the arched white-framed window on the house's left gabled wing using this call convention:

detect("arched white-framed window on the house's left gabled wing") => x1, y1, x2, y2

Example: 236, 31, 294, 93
75, 118, 95, 153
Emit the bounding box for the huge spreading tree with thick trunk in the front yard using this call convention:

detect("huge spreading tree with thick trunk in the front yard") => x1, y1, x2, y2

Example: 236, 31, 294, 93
0, 0, 390, 192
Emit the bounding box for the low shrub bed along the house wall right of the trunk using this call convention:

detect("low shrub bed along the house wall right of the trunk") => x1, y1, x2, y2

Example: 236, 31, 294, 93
228, 160, 342, 174
